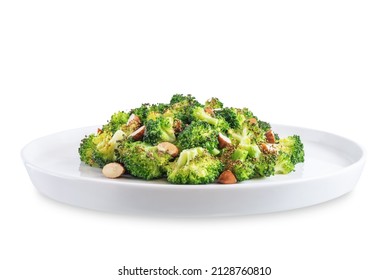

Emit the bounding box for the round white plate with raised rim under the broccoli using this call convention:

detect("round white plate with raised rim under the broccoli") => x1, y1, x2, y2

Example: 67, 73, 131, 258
22, 125, 365, 216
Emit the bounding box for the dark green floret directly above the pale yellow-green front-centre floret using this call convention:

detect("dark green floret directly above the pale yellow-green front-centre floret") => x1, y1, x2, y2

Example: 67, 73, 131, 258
177, 121, 219, 155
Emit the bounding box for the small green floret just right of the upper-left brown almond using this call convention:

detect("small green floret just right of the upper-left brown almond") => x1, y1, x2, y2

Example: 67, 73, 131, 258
143, 116, 176, 145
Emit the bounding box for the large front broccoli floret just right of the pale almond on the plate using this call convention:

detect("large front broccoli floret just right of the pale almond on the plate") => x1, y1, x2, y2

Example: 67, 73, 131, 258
119, 142, 172, 180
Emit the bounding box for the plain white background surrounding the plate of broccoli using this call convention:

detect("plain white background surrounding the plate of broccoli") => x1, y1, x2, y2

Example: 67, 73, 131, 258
0, 0, 389, 279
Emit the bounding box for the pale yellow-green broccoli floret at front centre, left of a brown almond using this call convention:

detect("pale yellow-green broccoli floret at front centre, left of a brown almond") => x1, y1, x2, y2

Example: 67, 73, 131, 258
167, 148, 223, 184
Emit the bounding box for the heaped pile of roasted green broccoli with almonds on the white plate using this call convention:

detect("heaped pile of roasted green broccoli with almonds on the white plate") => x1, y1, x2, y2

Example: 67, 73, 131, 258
78, 94, 304, 184
